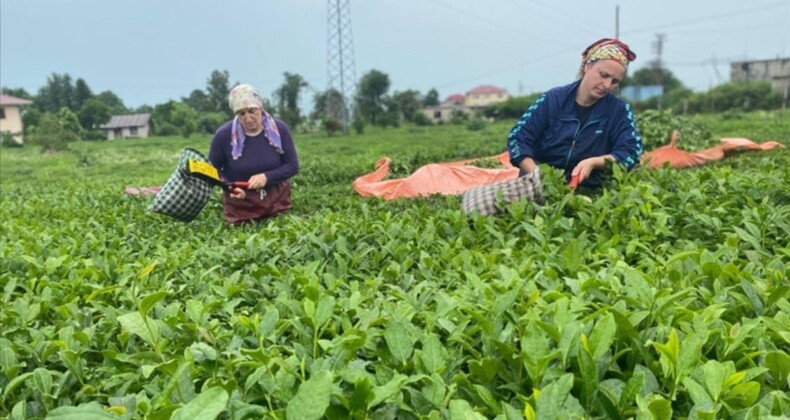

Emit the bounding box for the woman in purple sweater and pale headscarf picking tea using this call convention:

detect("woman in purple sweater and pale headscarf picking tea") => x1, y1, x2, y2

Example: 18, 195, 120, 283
208, 85, 299, 224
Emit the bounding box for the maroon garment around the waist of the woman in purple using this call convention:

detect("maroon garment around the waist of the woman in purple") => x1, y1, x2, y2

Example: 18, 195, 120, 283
222, 181, 291, 224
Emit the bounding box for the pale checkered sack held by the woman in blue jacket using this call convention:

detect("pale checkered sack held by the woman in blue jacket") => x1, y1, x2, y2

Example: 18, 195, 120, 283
461, 170, 546, 216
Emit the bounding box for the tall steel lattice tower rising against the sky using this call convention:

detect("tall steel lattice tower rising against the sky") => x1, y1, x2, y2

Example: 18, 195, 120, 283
326, 0, 356, 134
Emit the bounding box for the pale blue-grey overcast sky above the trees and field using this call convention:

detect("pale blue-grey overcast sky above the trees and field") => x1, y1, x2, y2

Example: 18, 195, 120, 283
0, 0, 790, 107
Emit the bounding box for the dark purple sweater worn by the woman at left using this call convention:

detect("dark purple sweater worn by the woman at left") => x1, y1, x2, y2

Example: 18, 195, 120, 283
208, 120, 299, 185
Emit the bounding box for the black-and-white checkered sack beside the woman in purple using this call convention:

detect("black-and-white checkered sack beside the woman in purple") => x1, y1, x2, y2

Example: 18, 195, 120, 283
148, 148, 211, 222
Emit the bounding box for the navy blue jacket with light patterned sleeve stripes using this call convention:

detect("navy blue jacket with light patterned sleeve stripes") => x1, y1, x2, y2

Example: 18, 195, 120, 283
507, 80, 642, 187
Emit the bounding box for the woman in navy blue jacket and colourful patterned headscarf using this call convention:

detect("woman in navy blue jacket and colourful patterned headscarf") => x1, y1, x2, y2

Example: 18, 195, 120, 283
507, 38, 642, 187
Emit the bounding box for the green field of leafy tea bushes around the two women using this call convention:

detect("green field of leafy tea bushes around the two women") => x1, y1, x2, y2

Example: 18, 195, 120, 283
0, 112, 790, 420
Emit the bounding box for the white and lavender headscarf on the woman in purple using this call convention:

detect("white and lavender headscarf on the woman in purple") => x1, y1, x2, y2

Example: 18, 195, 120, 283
228, 85, 284, 160
